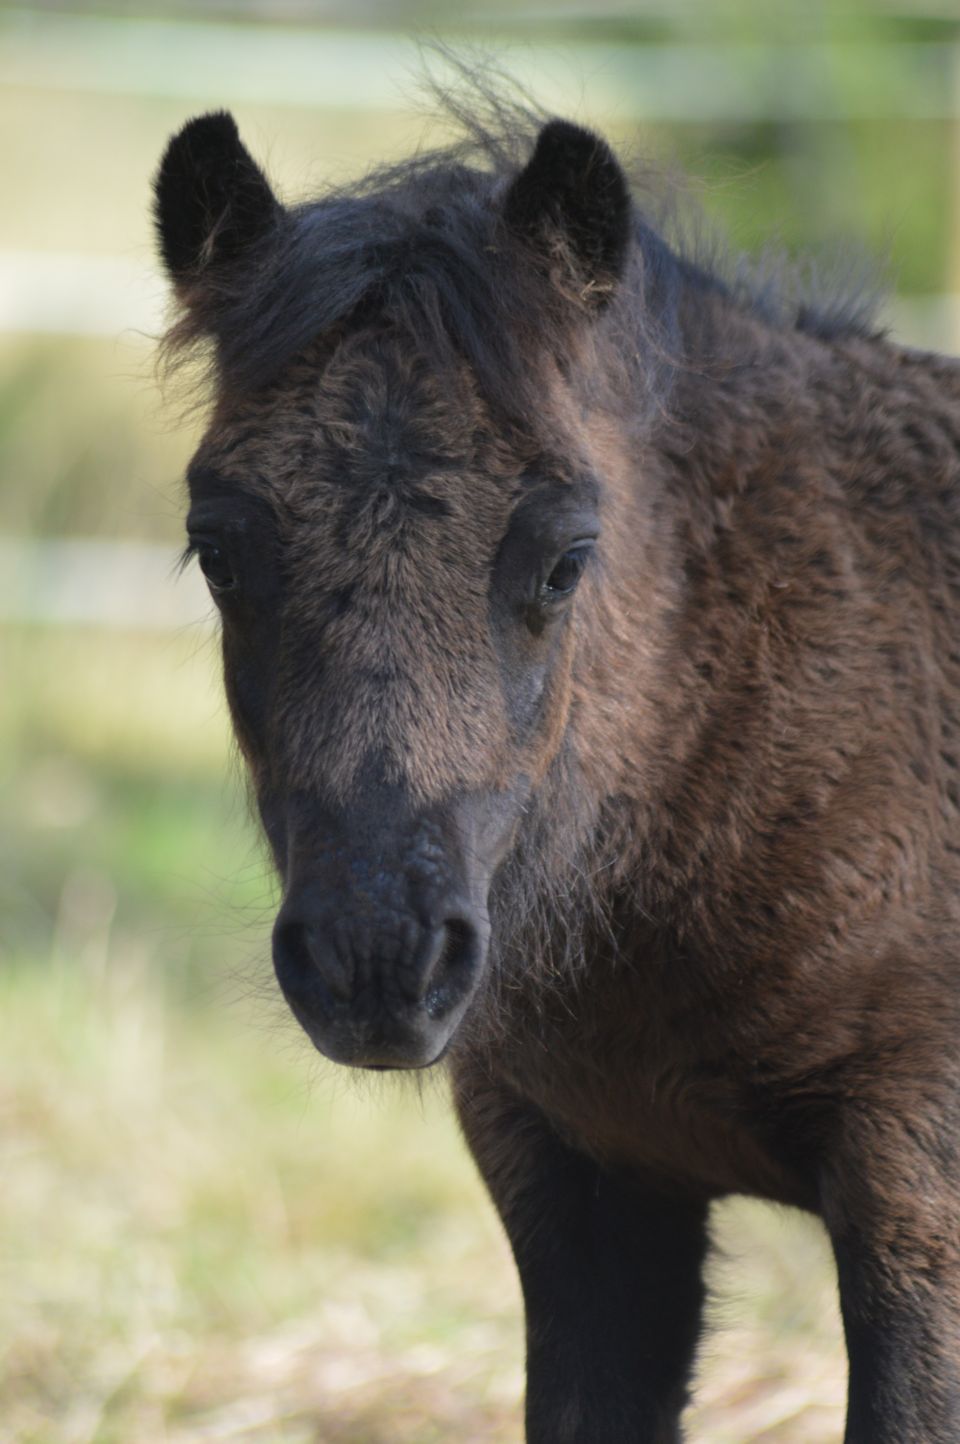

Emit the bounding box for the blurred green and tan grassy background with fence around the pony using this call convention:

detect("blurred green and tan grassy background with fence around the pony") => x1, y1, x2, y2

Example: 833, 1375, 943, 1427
0, 0, 960, 1444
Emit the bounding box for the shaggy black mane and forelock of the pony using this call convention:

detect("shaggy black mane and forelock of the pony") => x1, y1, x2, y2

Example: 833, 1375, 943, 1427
160, 55, 878, 417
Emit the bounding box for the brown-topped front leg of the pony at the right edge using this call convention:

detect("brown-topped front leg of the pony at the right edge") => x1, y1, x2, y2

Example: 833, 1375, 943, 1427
823, 1087, 960, 1444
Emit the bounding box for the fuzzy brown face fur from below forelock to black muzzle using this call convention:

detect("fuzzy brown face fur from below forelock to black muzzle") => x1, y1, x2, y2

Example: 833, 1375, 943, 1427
191, 334, 600, 799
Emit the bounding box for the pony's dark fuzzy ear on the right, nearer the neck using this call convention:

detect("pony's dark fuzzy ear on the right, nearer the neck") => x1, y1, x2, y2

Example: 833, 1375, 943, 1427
504, 120, 632, 306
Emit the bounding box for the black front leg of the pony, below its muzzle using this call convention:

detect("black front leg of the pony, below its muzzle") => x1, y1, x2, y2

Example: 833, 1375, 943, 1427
455, 1067, 707, 1444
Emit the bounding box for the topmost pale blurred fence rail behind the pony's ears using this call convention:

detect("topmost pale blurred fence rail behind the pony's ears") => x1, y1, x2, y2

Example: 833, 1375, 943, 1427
0, 9, 960, 121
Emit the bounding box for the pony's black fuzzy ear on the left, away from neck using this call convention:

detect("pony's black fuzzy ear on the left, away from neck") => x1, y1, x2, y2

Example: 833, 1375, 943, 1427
153, 110, 282, 289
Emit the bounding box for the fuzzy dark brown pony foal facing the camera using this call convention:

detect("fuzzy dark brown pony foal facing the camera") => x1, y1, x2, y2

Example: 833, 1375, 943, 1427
156, 101, 960, 1444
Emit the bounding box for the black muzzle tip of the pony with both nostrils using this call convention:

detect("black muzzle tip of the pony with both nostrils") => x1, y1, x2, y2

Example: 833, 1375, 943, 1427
273, 888, 486, 1069
